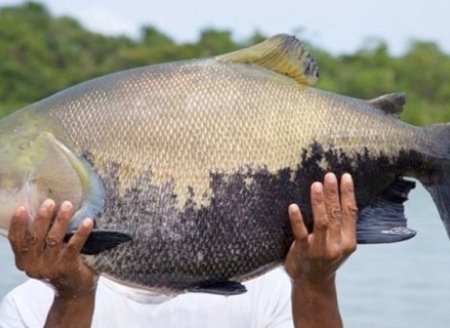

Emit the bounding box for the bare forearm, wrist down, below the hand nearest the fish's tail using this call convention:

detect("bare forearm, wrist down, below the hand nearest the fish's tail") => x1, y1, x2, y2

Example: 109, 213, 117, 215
292, 278, 342, 328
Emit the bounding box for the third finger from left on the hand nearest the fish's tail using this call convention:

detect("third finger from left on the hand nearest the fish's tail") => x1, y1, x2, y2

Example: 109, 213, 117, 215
324, 173, 342, 243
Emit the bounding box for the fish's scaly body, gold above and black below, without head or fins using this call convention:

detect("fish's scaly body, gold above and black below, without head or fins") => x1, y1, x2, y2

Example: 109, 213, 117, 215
0, 35, 450, 292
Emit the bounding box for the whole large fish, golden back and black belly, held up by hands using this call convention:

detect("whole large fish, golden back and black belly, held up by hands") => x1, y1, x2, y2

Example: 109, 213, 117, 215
0, 35, 450, 294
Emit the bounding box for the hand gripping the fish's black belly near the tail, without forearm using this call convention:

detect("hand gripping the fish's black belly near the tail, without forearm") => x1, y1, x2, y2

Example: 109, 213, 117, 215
285, 173, 357, 284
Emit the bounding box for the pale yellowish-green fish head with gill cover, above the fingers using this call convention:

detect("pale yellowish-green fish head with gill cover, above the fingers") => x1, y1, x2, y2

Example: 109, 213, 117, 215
0, 116, 103, 236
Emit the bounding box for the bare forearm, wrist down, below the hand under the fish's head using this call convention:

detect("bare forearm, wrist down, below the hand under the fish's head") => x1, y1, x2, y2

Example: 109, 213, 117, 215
45, 290, 95, 328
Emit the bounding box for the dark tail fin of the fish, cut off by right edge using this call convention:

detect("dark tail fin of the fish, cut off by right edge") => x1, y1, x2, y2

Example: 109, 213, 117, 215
420, 123, 450, 238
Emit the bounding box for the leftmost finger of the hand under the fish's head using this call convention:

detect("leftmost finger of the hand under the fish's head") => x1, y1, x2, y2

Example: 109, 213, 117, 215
8, 206, 28, 270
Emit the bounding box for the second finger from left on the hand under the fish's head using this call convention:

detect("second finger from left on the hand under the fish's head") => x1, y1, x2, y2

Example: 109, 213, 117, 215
26, 199, 55, 252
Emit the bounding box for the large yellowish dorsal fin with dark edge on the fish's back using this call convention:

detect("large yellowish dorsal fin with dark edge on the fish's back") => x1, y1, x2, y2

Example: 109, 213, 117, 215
216, 34, 319, 85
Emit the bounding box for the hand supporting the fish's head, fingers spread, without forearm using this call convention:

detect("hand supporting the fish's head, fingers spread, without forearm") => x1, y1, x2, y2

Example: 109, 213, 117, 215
8, 200, 97, 298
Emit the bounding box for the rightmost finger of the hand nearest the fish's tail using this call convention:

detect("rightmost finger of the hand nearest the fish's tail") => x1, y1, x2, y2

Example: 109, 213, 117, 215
340, 173, 358, 252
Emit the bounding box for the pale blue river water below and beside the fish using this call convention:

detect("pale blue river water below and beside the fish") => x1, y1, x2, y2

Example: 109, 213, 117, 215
0, 186, 450, 328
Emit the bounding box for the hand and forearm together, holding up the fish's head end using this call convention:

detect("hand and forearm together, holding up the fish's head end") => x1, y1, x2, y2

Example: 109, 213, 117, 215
8, 200, 98, 327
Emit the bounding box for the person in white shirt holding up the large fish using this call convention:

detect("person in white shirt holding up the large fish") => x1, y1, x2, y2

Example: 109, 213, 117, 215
0, 173, 357, 328
